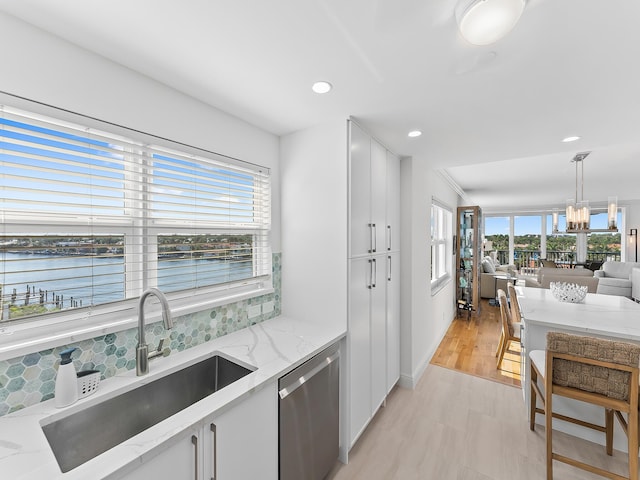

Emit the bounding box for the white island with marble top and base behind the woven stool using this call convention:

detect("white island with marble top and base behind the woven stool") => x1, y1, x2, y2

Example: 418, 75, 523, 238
516, 286, 640, 452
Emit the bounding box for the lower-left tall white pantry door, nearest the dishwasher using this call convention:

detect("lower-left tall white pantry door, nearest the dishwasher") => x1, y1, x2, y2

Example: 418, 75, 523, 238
348, 258, 373, 445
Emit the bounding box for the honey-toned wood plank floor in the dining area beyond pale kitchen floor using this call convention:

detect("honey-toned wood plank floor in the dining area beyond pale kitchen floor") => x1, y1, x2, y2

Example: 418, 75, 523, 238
431, 300, 520, 387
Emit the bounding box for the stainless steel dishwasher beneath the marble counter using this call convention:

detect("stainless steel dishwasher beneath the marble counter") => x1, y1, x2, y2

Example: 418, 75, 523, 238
278, 343, 340, 480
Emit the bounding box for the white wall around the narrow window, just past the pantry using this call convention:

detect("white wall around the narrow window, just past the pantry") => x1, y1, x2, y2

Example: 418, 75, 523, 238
400, 158, 459, 387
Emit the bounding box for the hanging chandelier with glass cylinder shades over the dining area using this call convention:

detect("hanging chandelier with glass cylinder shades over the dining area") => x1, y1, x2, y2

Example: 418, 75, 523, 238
552, 152, 618, 233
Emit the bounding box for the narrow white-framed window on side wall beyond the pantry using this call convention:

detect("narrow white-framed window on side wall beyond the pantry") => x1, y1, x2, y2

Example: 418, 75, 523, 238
431, 199, 453, 293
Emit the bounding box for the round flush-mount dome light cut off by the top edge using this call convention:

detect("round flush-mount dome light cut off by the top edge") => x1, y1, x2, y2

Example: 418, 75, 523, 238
457, 0, 525, 45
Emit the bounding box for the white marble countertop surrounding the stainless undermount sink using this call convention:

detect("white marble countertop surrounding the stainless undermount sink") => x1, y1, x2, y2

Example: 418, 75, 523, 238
0, 317, 346, 480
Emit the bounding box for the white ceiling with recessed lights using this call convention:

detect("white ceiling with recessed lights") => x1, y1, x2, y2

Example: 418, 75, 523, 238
0, 0, 640, 210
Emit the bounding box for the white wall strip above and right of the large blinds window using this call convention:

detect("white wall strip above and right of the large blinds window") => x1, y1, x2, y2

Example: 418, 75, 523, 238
0, 13, 280, 252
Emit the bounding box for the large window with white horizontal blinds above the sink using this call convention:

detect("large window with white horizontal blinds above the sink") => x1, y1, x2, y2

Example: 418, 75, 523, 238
0, 107, 271, 321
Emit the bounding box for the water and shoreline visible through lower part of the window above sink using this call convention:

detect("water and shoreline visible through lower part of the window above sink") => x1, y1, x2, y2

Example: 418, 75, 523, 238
0, 235, 253, 320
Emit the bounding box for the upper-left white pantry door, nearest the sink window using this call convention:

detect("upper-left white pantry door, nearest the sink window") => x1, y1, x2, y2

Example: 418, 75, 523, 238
349, 122, 374, 257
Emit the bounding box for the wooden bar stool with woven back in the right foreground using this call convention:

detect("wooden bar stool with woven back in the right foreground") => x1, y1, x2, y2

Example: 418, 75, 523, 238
529, 332, 640, 480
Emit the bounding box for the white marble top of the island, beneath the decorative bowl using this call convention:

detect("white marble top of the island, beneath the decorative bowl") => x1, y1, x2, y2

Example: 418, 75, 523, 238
517, 287, 640, 342
